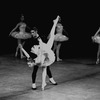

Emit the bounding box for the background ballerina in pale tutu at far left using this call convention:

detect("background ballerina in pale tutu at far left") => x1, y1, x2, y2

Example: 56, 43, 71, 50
9, 15, 31, 59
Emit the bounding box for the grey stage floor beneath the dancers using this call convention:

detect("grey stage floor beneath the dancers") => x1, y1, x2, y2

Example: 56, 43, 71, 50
0, 55, 100, 100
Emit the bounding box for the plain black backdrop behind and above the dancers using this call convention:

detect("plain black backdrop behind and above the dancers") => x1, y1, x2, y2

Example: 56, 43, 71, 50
0, 1, 100, 58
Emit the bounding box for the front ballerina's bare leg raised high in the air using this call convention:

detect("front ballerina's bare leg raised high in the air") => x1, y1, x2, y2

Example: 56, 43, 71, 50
47, 16, 60, 49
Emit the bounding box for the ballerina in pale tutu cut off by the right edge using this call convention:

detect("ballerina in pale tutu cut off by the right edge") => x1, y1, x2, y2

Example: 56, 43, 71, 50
92, 28, 100, 64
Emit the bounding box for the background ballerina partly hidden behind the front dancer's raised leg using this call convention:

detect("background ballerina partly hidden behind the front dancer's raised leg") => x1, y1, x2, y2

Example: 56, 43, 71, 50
48, 22, 69, 61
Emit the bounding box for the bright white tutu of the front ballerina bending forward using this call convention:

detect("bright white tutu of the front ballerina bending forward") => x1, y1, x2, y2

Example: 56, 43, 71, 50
31, 45, 55, 67
